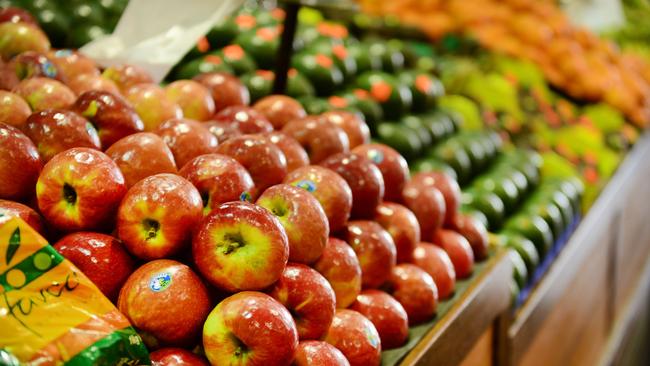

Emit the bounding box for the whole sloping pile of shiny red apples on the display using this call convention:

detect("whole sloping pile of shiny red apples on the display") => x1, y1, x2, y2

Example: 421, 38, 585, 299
0, 7, 487, 365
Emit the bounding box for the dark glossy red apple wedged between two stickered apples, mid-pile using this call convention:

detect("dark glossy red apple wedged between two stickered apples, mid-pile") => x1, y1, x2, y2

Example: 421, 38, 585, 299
320, 153, 384, 219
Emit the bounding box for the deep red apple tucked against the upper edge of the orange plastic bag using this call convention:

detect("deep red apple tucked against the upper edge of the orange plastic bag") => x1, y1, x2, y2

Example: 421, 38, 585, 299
53, 232, 135, 301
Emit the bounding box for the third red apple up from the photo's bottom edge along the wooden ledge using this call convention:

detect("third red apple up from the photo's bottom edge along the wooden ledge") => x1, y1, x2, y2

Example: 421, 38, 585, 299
350, 290, 409, 350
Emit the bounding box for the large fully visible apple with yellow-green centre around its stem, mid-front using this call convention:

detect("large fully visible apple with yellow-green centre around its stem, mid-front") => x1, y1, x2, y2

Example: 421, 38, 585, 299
192, 201, 289, 292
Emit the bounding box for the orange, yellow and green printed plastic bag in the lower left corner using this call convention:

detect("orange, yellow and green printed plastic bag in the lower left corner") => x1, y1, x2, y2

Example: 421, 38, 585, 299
0, 216, 150, 366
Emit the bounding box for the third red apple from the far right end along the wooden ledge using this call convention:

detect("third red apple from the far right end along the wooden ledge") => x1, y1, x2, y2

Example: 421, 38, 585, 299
413, 242, 456, 299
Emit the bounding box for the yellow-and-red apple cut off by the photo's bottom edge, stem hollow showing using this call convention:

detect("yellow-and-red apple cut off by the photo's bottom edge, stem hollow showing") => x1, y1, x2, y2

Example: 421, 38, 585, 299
203, 291, 298, 366
